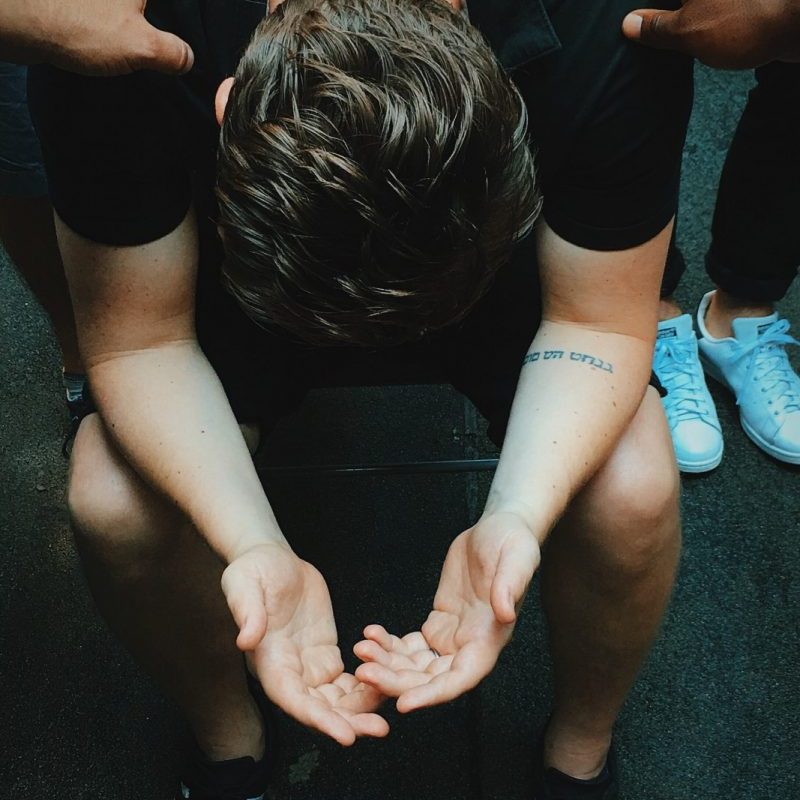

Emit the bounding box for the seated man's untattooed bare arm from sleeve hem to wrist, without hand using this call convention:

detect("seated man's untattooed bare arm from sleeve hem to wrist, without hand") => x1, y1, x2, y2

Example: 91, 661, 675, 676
57, 214, 285, 562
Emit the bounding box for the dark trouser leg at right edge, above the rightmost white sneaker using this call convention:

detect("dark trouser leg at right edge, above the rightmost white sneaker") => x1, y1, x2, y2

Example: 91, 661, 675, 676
707, 62, 800, 302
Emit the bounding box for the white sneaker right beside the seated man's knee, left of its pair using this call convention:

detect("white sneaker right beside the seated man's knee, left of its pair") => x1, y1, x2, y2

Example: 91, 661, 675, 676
653, 314, 724, 473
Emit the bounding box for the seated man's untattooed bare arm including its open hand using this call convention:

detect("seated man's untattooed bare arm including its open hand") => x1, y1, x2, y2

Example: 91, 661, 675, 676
57, 213, 388, 745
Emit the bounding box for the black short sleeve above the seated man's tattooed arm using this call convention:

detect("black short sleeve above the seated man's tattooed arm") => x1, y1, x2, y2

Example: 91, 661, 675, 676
506, 0, 693, 251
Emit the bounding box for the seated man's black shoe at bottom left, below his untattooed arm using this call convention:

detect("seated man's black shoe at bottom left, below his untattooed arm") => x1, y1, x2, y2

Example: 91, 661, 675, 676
175, 676, 276, 800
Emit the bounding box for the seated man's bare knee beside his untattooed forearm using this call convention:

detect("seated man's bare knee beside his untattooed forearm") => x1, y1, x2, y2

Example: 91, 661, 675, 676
67, 414, 178, 572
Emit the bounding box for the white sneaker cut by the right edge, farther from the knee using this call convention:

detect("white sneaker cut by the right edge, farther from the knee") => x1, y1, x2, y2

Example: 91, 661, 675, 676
697, 292, 800, 464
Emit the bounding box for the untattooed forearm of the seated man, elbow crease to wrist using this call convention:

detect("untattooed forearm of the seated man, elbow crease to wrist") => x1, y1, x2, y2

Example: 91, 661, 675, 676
89, 340, 285, 561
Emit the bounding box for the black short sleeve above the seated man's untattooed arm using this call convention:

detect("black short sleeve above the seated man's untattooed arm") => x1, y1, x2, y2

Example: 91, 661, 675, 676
29, 67, 192, 245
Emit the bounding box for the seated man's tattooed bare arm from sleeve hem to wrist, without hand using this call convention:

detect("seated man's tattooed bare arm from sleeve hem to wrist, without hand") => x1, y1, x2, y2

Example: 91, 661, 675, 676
484, 219, 672, 543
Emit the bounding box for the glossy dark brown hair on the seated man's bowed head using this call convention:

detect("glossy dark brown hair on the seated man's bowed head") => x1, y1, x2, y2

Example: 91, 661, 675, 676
217, 0, 540, 345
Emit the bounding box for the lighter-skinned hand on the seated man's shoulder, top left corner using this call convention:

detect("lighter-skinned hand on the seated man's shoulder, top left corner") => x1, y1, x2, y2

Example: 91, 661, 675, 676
0, 0, 194, 75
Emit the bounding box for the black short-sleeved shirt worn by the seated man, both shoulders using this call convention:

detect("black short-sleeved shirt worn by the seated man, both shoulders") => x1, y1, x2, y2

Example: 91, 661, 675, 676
30, 0, 691, 250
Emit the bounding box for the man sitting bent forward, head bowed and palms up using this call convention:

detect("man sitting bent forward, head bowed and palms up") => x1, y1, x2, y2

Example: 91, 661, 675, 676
32, 0, 691, 799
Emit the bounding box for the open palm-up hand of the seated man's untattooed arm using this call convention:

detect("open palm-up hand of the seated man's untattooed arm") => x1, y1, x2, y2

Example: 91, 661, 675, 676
222, 544, 389, 746
